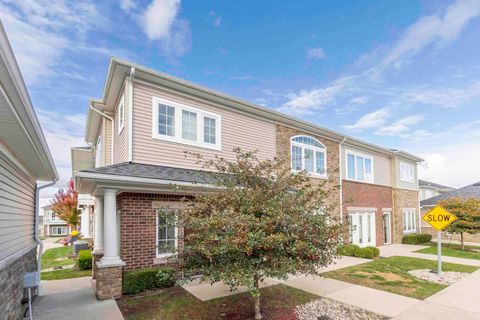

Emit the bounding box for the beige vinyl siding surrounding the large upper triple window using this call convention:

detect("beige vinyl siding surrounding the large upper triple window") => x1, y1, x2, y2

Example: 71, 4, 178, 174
132, 82, 275, 169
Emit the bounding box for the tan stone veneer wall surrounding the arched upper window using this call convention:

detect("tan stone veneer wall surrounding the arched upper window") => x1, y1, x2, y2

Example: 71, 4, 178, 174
276, 125, 340, 216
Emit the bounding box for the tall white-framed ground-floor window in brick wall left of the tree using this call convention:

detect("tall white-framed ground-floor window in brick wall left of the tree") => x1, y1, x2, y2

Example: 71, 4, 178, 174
157, 209, 177, 257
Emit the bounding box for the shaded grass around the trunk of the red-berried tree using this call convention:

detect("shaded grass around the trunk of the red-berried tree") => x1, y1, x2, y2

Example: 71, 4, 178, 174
118, 285, 319, 320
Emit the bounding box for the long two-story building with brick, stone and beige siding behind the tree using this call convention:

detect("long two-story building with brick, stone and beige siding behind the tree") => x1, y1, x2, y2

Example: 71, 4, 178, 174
72, 58, 422, 299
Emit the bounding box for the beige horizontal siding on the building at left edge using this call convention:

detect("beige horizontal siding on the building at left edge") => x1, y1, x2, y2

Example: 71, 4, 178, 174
0, 152, 35, 261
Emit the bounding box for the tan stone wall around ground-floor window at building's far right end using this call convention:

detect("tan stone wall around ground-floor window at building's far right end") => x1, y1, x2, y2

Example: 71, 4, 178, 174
392, 188, 420, 243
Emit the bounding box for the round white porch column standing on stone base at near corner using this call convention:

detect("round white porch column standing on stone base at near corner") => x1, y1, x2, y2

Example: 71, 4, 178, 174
100, 189, 125, 266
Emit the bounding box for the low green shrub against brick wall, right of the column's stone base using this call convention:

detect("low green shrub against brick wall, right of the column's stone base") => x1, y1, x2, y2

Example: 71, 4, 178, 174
123, 268, 175, 294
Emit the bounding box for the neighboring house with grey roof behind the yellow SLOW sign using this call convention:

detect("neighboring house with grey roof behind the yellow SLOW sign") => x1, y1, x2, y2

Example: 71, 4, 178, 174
420, 182, 480, 242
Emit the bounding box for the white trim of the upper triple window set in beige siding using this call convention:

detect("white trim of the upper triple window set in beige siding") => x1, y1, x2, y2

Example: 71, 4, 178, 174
152, 97, 222, 150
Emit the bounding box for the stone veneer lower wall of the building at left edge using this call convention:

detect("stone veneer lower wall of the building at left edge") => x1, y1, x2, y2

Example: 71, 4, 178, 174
0, 247, 37, 319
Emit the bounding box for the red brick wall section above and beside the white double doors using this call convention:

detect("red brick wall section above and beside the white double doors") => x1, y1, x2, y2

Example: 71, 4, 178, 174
342, 180, 393, 246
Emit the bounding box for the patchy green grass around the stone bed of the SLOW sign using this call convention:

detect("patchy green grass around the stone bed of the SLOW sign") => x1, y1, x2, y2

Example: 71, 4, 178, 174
323, 257, 478, 300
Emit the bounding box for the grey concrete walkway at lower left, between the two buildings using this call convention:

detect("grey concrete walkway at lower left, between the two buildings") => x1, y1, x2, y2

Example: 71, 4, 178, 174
33, 277, 123, 320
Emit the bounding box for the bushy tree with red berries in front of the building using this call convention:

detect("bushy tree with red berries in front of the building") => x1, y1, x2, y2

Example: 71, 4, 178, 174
176, 148, 345, 319
